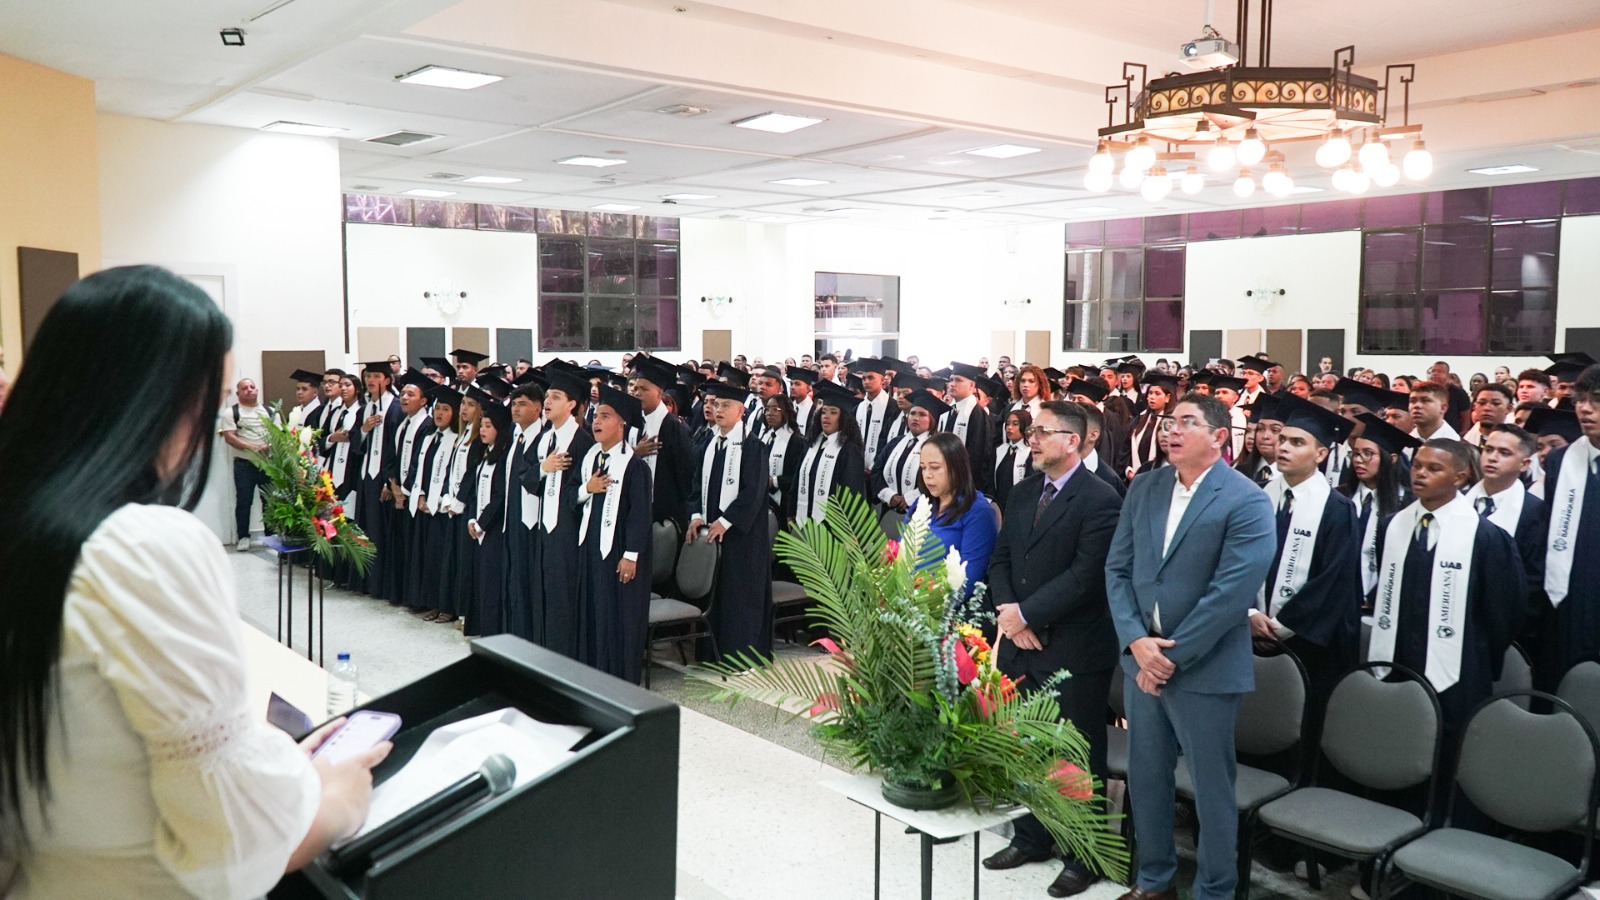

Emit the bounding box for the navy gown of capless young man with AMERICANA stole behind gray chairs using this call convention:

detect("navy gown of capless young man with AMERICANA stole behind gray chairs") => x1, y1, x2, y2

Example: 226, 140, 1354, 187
1376, 519, 1523, 730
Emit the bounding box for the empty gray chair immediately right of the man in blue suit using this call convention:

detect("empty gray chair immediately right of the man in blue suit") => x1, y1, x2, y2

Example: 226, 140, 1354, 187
1173, 644, 1310, 886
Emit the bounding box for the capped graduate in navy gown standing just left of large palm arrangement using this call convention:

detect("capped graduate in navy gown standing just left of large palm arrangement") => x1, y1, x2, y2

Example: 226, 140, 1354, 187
683, 381, 773, 661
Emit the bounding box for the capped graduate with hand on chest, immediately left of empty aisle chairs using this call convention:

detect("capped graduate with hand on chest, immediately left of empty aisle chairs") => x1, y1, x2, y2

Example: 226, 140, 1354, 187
578, 384, 653, 684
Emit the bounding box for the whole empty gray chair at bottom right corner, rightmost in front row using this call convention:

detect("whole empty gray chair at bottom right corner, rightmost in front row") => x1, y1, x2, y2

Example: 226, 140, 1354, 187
1379, 690, 1600, 900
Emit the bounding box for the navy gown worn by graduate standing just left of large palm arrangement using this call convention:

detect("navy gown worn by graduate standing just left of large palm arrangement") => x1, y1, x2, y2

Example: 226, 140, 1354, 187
690, 429, 777, 661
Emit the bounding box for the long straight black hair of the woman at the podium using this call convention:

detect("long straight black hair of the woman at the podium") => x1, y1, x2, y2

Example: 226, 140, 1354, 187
0, 266, 234, 832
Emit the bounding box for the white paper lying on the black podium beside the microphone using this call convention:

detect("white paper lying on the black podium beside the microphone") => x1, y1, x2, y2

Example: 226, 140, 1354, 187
357, 708, 589, 834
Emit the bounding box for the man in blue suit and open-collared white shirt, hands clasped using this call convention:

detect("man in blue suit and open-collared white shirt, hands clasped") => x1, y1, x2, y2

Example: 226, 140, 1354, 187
1106, 394, 1277, 900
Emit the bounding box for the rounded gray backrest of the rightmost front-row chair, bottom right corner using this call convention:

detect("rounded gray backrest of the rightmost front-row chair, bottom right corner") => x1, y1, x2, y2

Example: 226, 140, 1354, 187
1456, 690, 1600, 831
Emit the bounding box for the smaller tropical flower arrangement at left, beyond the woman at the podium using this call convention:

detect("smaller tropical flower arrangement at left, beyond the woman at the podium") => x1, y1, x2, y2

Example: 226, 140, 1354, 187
251, 405, 374, 573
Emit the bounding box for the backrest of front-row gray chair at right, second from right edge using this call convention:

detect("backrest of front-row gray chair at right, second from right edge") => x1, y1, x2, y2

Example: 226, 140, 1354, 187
1322, 663, 1442, 791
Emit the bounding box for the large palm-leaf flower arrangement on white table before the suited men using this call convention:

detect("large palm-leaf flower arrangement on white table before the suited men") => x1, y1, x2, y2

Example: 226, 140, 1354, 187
704, 492, 1128, 879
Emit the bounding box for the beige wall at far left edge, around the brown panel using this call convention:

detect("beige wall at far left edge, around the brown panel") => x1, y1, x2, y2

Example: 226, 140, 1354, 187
0, 54, 101, 375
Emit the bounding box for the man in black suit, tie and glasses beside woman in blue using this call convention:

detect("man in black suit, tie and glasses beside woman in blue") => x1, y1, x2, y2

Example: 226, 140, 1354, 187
984, 400, 1122, 897
